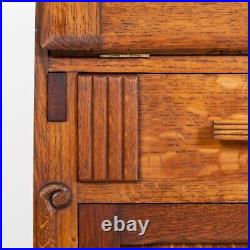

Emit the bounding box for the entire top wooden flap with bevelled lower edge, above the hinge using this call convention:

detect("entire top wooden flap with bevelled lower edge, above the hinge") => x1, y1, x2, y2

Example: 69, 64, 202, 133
41, 2, 248, 55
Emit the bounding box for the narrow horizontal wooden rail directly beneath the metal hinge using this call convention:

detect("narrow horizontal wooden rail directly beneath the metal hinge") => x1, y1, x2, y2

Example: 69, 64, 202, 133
49, 55, 248, 74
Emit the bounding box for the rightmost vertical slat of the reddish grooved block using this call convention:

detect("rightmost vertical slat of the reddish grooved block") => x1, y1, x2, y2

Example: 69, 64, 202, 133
123, 76, 138, 181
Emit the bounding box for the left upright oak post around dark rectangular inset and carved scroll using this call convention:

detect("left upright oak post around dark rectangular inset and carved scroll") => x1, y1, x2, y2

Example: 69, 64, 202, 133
34, 6, 78, 248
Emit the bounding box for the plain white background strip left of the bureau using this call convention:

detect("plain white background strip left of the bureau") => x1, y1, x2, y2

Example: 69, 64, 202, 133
2, 2, 35, 248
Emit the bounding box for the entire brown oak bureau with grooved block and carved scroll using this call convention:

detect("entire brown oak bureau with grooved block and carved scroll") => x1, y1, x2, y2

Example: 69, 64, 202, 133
34, 2, 248, 248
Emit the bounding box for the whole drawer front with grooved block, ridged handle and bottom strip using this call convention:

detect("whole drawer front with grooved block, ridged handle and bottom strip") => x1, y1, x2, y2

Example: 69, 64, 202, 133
78, 74, 248, 202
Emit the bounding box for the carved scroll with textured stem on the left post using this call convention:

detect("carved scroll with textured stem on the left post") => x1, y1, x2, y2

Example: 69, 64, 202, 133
38, 183, 71, 248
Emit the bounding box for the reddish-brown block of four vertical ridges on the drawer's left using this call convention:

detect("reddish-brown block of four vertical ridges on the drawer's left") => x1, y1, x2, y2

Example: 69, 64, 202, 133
78, 75, 138, 182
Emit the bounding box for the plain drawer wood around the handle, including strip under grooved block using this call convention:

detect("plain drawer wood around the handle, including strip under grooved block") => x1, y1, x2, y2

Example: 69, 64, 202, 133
79, 74, 248, 202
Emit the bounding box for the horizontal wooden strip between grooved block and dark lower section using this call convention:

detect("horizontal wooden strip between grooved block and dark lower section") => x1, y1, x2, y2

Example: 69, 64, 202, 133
78, 181, 248, 203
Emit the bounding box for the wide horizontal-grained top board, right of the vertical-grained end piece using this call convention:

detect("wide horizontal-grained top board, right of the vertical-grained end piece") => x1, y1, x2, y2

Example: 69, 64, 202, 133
101, 2, 248, 54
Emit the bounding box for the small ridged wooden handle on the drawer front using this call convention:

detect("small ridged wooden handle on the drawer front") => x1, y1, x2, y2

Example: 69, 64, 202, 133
213, 120, 248, 141
